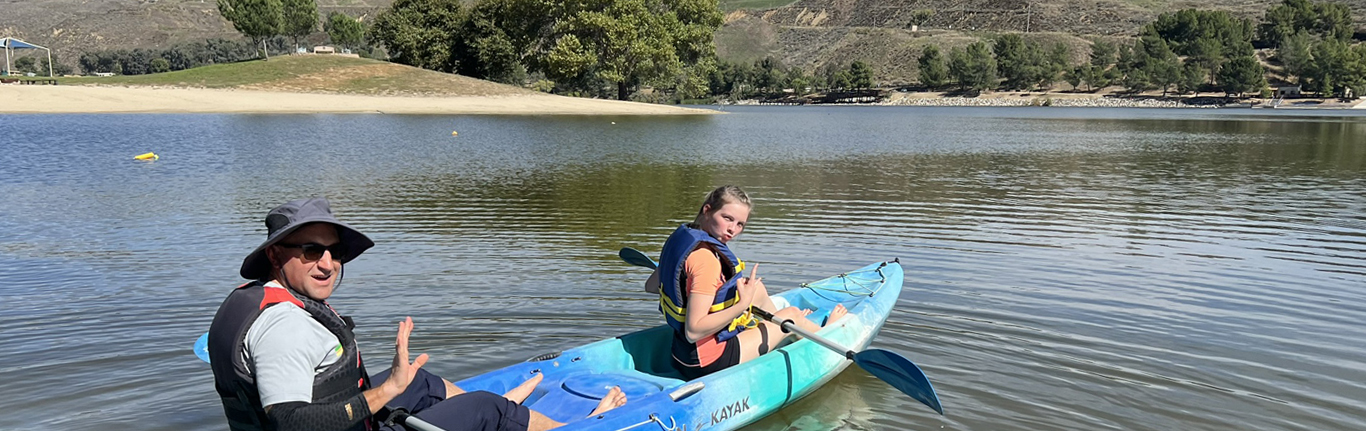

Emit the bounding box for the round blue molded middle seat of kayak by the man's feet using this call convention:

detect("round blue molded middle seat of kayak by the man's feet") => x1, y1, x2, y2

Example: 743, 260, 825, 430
529, 371, 683, 423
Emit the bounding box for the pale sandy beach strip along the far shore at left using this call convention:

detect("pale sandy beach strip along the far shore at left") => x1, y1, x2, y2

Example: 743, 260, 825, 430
0, 85, 719, 115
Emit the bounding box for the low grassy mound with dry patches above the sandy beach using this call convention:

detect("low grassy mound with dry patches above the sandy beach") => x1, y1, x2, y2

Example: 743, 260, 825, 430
59, 56, 531, 95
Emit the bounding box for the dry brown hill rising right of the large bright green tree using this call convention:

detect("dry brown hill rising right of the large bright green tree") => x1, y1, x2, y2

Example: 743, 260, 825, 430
716, 0, 1366, 85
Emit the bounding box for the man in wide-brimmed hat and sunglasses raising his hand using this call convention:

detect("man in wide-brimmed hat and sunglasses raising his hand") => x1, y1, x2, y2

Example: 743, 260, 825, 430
209, 198, 626, 431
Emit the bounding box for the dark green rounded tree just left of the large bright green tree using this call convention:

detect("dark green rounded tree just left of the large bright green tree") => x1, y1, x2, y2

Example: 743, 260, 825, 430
370, 0, 464, 72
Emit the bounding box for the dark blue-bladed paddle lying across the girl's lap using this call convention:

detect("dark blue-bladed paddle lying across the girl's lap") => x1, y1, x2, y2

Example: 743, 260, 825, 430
617, 247, 944, 415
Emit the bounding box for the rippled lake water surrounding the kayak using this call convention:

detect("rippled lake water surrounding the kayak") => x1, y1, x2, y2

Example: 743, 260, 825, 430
0, 106, 1366, 430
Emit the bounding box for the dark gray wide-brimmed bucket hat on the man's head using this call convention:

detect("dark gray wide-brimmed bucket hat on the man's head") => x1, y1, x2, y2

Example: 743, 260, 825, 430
239, 198, 374, 280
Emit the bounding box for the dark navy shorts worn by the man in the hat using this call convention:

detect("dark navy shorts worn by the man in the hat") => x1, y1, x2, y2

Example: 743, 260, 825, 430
373, 370, 531, 431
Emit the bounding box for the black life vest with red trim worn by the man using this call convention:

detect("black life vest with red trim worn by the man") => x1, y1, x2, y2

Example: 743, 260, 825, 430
209, 281, 377, 431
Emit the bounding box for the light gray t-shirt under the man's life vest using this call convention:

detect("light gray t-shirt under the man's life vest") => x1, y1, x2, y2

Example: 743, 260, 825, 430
243, 281, 344, 406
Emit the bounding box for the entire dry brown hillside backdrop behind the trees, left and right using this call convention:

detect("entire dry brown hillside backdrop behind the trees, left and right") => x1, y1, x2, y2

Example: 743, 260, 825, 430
0, 0, 1366, 83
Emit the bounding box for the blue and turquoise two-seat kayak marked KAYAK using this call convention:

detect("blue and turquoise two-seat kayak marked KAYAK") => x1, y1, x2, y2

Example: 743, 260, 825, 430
456, 262, 903, 431
